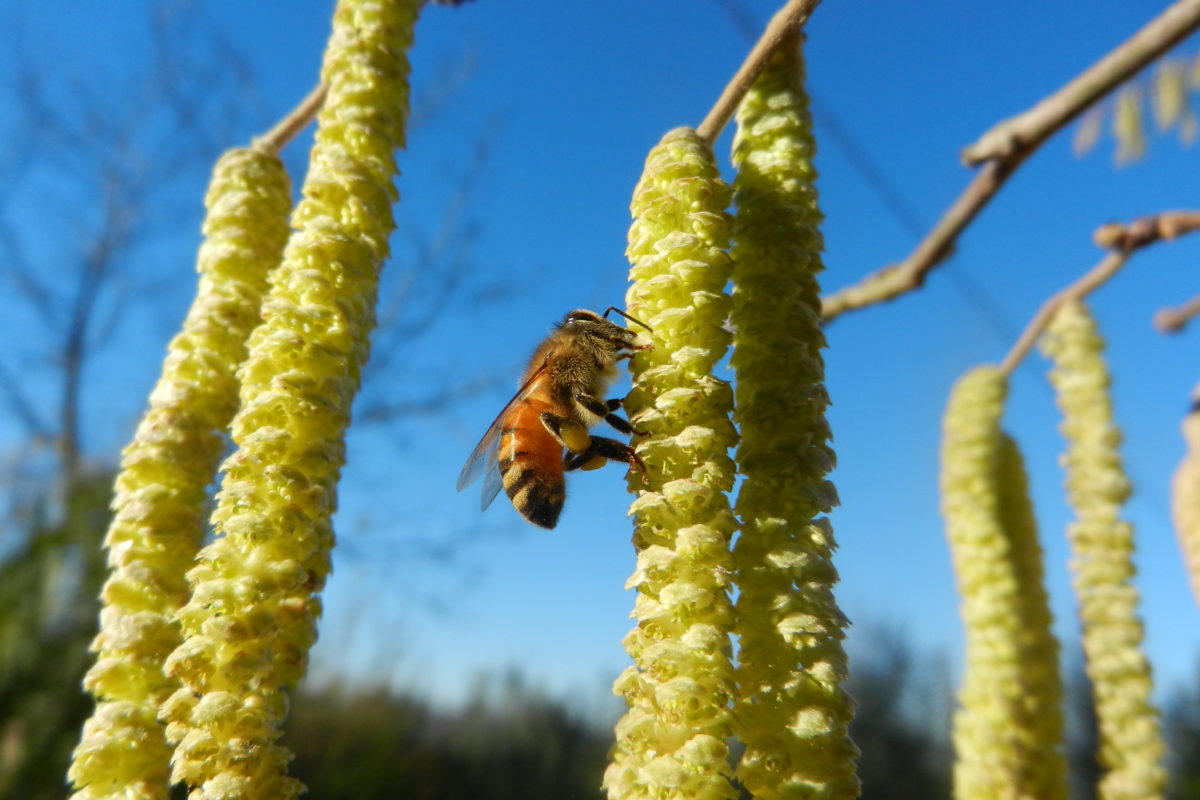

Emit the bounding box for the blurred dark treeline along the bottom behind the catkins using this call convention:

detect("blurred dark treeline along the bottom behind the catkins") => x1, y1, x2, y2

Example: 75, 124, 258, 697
0, 482, 1200, 800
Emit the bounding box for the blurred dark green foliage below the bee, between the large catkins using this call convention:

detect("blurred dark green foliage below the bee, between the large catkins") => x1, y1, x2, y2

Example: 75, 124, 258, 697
283, 678, 612, 800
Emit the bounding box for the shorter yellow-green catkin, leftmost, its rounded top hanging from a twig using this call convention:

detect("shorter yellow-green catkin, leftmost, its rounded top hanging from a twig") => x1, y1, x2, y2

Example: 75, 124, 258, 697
70, 148, 292, 800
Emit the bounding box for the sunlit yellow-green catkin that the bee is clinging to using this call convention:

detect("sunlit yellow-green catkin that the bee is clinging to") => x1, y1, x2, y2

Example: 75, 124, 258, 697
604, 128, 737, 800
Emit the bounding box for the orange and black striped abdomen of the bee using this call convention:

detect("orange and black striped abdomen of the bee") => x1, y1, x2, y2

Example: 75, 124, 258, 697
496, 398, 566, 528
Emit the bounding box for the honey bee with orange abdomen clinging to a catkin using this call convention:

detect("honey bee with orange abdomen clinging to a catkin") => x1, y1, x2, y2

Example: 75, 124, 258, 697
458, 307, 653, 528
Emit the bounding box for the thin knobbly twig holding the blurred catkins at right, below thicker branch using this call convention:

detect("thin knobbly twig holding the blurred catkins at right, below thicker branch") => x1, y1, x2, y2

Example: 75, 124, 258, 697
1000, 211, 1200, 374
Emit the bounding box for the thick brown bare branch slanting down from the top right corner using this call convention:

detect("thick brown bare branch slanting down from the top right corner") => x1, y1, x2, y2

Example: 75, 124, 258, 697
822, 0, 1200, 321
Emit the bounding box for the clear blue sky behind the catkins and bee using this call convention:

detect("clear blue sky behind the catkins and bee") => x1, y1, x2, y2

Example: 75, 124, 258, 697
9, 0, 1200, 703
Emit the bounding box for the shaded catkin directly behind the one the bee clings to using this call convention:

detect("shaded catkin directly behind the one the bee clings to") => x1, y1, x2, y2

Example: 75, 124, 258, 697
732, 40, 859, 800
